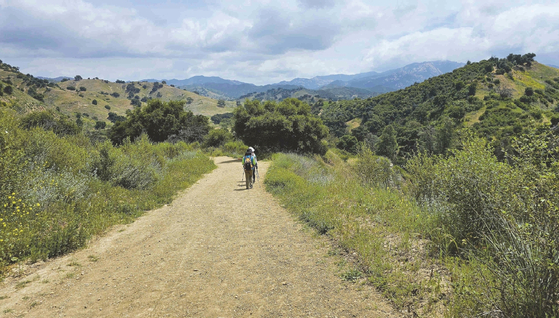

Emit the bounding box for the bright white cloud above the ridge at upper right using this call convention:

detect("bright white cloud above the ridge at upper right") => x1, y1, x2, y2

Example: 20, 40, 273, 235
365, 4, 559, 71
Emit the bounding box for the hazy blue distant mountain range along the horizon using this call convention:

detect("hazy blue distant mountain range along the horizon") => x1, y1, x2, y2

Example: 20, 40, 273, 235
41, 61, 464, 100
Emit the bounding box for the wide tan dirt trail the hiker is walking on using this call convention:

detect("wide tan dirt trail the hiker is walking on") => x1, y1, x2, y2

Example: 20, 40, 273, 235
0, 157, 396, 317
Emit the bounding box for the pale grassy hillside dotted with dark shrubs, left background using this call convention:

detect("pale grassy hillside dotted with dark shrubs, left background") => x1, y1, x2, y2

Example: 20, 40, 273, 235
0, 64, 236, 122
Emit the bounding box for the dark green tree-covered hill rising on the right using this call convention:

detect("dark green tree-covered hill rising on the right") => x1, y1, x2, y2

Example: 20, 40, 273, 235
313, 54, 559, 158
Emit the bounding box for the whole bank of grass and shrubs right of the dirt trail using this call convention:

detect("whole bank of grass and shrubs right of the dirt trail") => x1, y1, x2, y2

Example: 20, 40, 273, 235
265, 126, 559, 317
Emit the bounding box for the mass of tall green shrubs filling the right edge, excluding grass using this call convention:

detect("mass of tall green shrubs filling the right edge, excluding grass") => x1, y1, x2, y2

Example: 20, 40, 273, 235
406, 130, 559, 317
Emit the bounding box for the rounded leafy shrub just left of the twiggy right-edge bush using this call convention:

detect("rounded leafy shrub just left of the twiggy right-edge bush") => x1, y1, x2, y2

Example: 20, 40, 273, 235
406, 137, 516, 251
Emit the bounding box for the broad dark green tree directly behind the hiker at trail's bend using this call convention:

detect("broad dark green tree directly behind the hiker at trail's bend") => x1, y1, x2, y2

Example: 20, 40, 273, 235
233, 98, 328, 153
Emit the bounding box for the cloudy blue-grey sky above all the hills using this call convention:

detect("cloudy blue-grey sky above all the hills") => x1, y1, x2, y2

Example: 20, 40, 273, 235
0, 0, 559, 84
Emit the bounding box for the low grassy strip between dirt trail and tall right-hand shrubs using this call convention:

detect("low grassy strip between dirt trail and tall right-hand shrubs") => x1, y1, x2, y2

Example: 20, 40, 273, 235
265, 151, 442, 317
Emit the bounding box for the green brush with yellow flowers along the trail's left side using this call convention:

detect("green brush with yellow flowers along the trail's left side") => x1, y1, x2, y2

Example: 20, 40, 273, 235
0, 108, 215, 270
